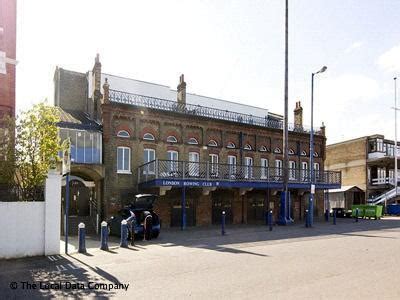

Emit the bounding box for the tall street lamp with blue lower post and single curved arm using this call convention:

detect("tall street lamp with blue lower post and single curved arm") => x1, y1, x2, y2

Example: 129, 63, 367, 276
308, 66, 327, 227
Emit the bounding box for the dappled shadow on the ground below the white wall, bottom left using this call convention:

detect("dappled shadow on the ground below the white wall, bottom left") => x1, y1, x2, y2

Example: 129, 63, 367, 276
0, 255, 121, 299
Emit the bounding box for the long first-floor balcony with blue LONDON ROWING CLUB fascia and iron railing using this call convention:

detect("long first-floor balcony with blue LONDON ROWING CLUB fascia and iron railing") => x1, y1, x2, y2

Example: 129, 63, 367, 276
138, 159, 341, 189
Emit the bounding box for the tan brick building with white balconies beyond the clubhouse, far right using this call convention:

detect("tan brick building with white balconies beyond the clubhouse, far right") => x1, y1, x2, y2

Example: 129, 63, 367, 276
325, 134, 400, 203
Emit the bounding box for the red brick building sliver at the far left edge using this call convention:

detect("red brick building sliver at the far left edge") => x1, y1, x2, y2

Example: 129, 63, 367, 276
0, 0, 17, 119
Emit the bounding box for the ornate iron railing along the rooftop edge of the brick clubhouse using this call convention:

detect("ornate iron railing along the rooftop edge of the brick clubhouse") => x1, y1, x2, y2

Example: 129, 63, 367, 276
109, 89, 322, 135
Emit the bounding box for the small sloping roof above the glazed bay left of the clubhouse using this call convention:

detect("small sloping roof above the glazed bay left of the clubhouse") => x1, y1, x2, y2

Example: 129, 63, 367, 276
56, 106, 101, 131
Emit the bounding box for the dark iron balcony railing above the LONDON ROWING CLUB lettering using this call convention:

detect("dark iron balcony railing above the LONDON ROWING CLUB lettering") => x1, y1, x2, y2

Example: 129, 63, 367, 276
138, 159, 341, 184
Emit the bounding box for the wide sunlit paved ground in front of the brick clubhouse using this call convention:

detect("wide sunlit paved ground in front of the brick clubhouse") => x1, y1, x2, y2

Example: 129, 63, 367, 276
0, 217, 400, 299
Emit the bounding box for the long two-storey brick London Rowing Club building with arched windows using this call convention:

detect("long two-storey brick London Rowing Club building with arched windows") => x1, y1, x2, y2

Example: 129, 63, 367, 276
54, 56, 340, 230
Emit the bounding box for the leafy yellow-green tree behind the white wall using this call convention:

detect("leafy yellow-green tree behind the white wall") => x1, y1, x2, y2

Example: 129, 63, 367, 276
10, 103, 61, 201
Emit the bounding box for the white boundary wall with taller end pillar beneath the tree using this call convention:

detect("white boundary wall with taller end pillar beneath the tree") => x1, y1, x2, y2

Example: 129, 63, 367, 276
0, 173, 61, 258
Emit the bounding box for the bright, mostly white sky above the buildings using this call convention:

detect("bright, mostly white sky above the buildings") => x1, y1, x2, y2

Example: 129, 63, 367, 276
17, 0, 400, 144
